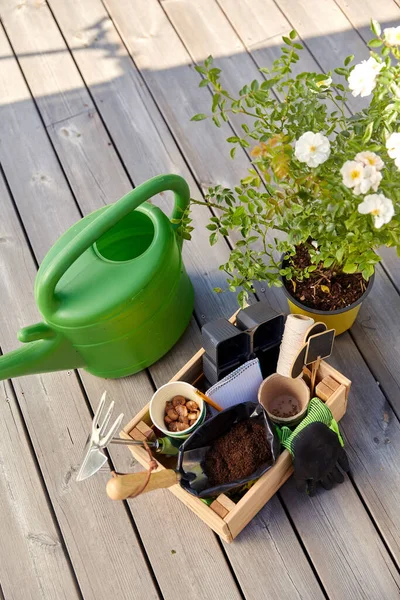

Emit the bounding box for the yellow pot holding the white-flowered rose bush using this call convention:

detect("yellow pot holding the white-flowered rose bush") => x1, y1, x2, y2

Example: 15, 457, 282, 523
281, 260, 375, 335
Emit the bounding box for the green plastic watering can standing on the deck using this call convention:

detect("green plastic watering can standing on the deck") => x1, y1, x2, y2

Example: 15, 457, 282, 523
0, 175, 194, 380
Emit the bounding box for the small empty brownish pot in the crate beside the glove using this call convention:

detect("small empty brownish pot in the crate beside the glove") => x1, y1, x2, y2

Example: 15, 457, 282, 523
258, 373, 310, 427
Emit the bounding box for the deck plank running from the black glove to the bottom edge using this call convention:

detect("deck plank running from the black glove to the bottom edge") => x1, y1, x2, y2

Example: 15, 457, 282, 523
281, 478, 400, 600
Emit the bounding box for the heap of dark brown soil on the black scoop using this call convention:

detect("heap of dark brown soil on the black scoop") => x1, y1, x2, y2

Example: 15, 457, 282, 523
204, 419, 271, 486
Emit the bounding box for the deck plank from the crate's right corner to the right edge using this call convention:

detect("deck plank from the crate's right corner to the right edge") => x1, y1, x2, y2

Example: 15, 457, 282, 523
331, 334, 400, 564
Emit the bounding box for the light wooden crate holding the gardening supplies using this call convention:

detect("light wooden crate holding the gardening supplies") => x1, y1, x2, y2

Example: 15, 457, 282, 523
121, 349, 351, 543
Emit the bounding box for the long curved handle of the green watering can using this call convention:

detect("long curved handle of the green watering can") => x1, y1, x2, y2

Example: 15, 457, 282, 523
36, 175, 190, 310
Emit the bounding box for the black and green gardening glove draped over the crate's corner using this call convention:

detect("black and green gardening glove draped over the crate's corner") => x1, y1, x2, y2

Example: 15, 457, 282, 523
278, 398, 350, 496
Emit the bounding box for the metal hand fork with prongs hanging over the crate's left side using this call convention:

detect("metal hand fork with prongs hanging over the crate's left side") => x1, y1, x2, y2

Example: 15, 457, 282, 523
76, 392, 179, 481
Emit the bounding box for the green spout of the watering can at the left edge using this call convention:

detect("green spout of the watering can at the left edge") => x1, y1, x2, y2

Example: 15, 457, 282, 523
0, 323, 85, 381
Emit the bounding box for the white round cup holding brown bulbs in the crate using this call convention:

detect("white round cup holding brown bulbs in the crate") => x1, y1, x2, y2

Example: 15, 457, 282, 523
149, 381, 206, 439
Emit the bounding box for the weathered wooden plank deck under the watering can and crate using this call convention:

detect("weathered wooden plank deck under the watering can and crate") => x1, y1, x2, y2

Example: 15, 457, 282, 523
0, 0, 400, 600
